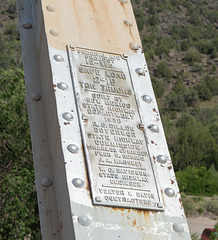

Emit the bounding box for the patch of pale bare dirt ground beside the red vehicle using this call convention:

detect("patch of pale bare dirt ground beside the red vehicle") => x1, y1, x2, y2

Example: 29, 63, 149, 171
187, 217, 217, 237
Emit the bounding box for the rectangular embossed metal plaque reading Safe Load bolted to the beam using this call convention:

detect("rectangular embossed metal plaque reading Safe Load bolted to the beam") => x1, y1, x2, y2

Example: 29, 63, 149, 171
69, 47, 163, 211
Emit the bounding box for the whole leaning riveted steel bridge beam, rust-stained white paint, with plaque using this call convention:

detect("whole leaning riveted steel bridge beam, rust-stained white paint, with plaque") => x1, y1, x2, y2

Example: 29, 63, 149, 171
18, 0, 191, 240
